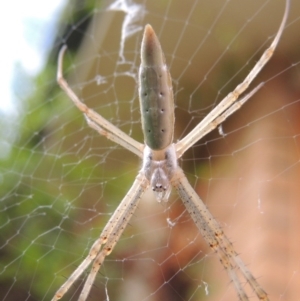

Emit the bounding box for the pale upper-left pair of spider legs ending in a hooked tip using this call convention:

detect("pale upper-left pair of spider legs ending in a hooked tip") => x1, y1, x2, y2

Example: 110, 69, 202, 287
57, 45, 144, 158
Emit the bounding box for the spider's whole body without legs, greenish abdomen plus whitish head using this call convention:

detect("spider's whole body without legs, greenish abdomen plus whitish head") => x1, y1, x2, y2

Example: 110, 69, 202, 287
139, 25, 177, 201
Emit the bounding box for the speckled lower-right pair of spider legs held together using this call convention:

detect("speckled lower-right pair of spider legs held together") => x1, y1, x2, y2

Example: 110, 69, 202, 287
171, 167, 269, 301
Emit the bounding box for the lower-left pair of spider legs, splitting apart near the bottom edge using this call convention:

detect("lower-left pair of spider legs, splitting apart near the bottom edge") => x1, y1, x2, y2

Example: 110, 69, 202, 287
52, 172, 149, 301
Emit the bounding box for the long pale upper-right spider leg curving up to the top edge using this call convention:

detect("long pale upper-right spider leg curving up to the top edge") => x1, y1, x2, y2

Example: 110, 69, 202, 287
176, 0, 290, 158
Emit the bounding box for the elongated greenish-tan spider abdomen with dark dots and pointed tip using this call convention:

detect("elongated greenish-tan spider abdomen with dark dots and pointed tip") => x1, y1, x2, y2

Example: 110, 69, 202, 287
139, 25, 174, 151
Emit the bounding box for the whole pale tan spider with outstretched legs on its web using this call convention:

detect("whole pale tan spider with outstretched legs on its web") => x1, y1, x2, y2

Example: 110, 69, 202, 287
52, 0, 290, 301
